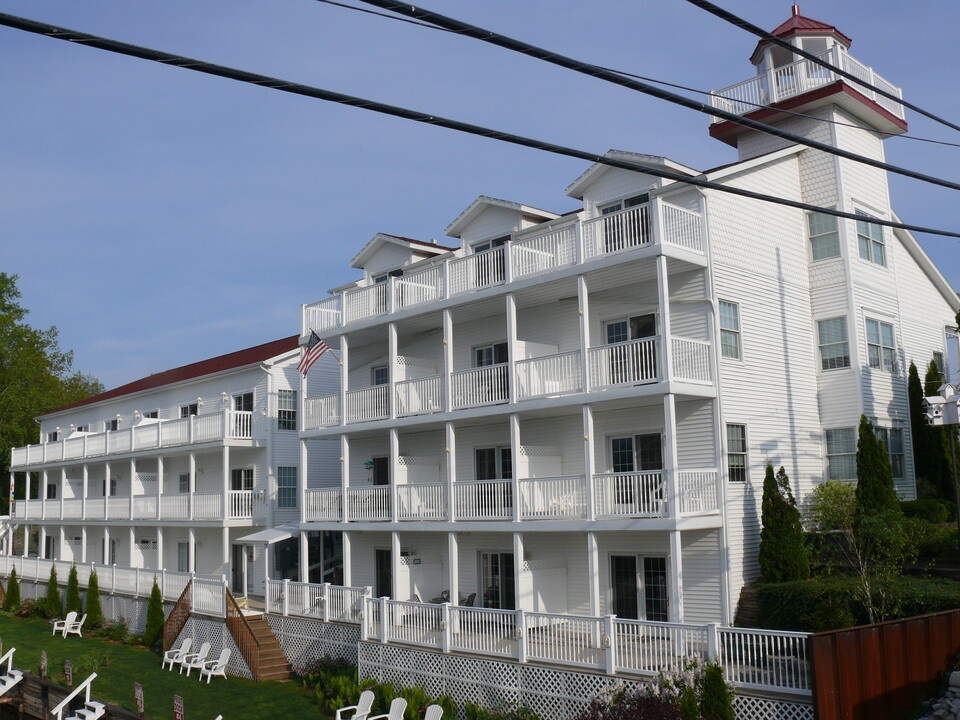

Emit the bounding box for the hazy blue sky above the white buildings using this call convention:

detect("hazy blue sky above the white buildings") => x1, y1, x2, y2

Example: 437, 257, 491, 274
0, 0, 960, 387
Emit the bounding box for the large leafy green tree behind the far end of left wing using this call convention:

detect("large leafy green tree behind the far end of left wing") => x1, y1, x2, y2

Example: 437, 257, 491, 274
0, 272, 103, 514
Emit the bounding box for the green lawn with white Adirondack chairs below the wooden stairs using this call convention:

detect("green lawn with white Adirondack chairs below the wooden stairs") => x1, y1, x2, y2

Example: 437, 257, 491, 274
0, 616, 321, 720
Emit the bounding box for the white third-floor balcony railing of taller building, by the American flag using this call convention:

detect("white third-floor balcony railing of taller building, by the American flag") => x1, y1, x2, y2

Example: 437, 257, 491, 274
303, 337, 711, 430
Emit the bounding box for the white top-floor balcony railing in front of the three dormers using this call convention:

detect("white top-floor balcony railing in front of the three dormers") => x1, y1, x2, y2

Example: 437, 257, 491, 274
303, 198, 706, 333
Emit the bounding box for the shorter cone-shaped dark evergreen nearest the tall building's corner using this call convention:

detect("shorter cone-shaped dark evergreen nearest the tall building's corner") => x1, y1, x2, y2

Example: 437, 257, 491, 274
760, 463, 810, 582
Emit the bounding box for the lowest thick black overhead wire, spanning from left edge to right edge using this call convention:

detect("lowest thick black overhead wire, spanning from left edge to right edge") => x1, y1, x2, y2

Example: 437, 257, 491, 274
0, 13, 960, 238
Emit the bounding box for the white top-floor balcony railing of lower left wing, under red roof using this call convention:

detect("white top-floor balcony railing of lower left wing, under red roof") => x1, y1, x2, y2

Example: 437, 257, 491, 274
10, 410, 263, 468
